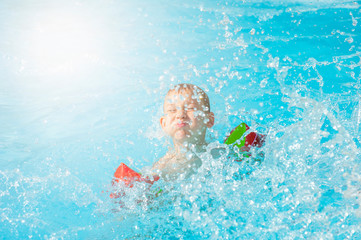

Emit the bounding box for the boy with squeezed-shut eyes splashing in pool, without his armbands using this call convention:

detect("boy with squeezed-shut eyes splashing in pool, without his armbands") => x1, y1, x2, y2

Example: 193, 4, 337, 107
152, 83, 214, 180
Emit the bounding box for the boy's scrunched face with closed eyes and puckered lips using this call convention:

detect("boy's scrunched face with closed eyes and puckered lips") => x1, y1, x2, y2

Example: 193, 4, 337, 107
160, 91, 214, 144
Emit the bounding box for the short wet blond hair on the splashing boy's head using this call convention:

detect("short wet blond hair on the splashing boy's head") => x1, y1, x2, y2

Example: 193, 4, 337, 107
166, 83, 211, 112
